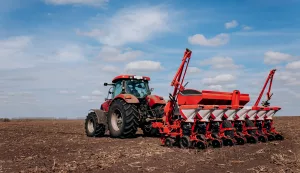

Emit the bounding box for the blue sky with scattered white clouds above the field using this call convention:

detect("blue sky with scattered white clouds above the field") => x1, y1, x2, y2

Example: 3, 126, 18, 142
0, 0, 300, 118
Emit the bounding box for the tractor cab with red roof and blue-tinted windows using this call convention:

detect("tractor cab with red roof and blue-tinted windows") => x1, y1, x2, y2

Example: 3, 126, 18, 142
104, 75, 153, 100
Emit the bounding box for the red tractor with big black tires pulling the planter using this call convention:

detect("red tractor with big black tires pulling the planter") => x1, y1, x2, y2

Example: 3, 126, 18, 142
85, 75, 166, 138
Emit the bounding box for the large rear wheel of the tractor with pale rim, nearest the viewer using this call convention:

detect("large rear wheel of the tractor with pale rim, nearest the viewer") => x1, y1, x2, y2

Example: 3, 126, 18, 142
107, 99, 139, 138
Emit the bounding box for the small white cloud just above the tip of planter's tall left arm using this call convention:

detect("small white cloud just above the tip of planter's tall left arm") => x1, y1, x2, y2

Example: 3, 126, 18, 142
188, 33, 229, 46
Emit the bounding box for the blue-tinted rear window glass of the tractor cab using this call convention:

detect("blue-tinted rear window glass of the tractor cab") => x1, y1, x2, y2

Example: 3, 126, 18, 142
126, 80, 150, 98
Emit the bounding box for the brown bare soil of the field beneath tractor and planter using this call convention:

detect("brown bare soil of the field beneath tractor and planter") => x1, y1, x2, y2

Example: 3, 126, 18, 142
0, 117, 300, 173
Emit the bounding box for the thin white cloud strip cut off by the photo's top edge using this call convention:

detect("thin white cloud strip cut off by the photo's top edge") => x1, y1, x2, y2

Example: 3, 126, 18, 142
44, 0, 109, 6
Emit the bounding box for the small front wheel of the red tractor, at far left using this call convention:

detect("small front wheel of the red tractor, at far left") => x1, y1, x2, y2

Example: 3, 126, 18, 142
85, 112, 106, 137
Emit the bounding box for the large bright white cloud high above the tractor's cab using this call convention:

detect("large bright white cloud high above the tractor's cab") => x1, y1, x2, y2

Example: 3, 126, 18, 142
77, 6, 174, 46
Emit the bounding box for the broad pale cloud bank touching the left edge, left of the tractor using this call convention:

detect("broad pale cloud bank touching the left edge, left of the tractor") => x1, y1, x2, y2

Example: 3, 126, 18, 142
0, 36, 92, 70
